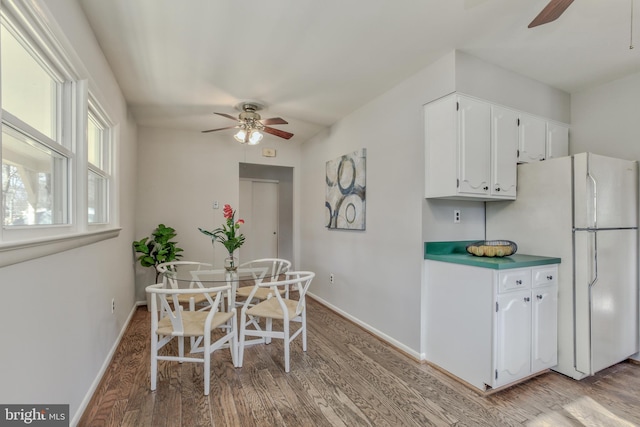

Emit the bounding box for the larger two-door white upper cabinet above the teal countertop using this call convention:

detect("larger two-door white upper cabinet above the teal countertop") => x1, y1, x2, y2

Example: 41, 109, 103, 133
424, 94, 518, 200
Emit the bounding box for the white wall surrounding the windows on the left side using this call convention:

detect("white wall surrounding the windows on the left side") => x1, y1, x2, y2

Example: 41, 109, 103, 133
0, 1, 136, 421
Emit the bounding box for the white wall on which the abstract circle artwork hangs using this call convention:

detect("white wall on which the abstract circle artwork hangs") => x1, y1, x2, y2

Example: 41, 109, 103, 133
301, 53, 454, 356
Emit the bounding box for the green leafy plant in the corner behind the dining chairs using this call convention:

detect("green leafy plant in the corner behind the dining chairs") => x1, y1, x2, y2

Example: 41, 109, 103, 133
133, 224, 183, 282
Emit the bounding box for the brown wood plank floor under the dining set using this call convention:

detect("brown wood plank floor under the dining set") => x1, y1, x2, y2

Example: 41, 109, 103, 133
78, 300, 640, 427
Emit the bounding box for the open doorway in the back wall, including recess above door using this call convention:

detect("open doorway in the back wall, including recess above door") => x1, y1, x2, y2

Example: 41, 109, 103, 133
238, 163, 293, 262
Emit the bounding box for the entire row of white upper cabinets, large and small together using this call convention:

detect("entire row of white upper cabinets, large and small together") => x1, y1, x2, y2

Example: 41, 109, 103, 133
424, 93, 569, 201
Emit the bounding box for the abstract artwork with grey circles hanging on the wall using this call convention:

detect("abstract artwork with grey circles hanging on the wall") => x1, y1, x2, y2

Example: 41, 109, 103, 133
325, 148, 367, 230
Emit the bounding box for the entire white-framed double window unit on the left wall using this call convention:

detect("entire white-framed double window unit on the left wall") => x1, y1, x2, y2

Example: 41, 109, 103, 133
0, 0, 117, 266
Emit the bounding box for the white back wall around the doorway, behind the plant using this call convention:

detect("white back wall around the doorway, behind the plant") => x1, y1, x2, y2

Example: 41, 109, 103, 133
136, 127, 300, 301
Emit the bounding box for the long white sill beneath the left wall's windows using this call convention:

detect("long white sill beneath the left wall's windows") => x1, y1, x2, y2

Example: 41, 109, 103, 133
0, 228, 121, 268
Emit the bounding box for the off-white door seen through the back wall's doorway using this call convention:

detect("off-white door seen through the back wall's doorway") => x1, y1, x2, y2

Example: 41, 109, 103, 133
239, 180, 279, 262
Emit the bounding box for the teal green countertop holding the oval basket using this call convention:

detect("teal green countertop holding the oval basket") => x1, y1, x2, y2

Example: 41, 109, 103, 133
424, 240, 560, 270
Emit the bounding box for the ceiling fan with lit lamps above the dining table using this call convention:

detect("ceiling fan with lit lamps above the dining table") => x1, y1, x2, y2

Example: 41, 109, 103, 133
202, 101, 293, 145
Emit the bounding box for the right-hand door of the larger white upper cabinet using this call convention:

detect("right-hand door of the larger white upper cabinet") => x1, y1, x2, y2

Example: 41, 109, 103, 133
490, 106, 518, 198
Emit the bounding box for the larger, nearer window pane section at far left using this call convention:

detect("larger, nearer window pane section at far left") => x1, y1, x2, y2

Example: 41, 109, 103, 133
0, 23, 72, 227
